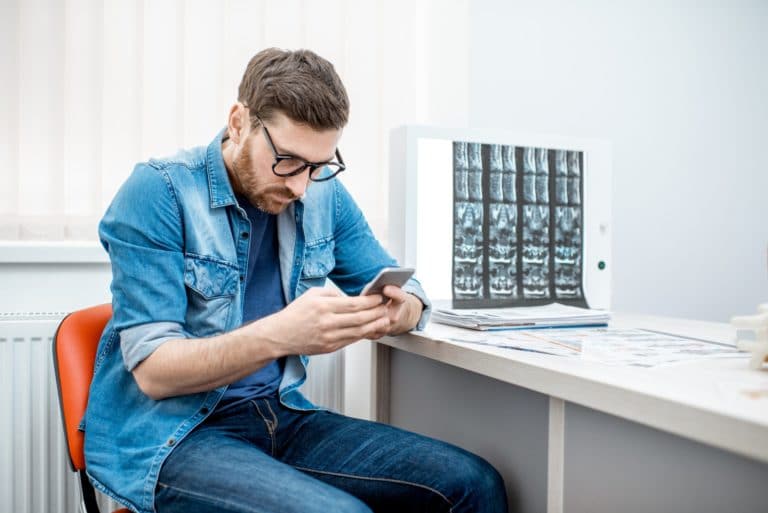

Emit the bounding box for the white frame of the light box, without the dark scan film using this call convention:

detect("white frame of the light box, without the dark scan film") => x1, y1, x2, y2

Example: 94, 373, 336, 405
388, 125, 612, 309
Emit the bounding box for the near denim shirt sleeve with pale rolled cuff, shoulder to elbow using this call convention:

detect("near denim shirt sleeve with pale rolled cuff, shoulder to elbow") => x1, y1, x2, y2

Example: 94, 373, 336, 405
99, 164, 187, 370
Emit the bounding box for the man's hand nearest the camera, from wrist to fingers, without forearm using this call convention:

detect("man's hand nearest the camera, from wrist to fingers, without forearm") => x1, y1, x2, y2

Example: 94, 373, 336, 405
256, 287, 390, 357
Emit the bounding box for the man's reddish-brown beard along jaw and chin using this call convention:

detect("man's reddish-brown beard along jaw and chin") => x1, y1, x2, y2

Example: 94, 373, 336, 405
232, 139, 298, 214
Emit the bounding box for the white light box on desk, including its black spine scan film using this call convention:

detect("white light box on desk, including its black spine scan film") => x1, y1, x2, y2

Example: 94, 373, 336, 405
389, 126, 611, 309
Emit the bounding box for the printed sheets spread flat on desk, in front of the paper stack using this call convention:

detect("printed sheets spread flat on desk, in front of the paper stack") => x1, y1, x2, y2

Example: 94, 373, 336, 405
432, 328, 749, 367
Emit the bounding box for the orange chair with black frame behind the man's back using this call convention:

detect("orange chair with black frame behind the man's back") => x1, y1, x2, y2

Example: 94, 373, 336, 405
53, 304, 129, 513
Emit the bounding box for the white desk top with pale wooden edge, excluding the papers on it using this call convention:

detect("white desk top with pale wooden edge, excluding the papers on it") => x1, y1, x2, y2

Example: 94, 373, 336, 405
380, 314, 768, 462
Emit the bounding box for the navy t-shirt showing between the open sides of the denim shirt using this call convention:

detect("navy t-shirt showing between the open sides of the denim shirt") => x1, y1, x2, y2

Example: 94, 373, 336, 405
219, 195, 285, 406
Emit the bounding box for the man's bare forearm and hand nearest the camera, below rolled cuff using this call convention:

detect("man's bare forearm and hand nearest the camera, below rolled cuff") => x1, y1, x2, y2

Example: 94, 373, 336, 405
133, 288, 390, 400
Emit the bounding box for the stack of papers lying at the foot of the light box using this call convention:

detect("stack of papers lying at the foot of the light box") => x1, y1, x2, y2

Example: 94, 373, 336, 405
432, 302, 610, 331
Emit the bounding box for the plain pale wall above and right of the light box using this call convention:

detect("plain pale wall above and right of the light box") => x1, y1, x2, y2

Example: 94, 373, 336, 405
469, 0, 768, 321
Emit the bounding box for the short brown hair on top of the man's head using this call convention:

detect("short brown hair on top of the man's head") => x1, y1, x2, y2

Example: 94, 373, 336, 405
238, 48, 349, 130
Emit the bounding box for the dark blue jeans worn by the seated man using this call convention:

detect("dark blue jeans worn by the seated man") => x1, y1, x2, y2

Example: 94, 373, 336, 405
155, 397, 507, 513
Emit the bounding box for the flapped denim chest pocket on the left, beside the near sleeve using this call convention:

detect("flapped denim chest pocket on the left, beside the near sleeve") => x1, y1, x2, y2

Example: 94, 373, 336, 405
184, 255, 239, 337
